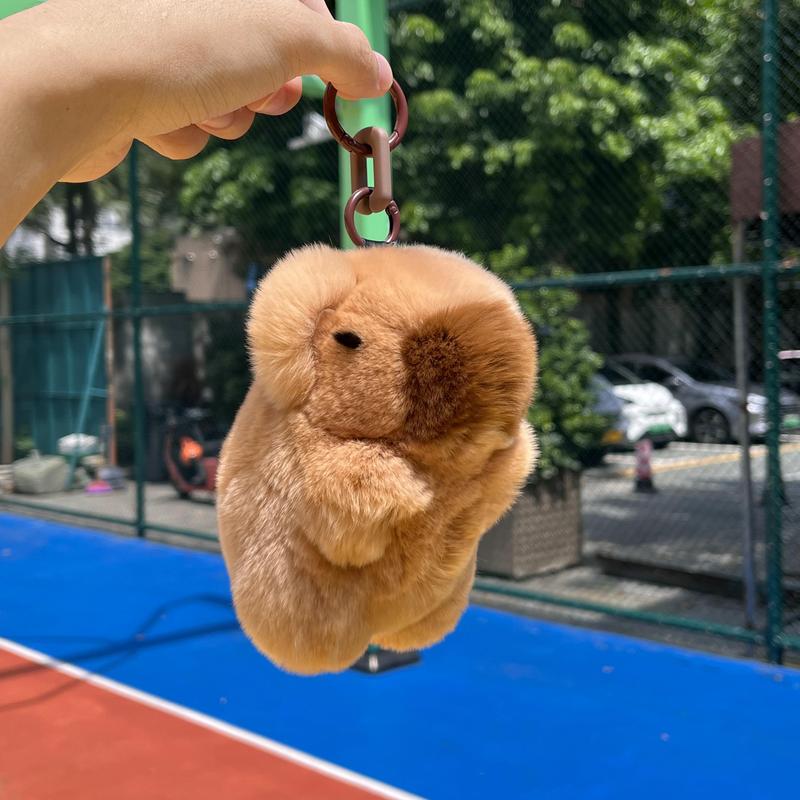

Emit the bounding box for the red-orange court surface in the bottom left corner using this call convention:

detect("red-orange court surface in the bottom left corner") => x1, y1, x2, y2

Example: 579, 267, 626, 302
0, 642, 411, 800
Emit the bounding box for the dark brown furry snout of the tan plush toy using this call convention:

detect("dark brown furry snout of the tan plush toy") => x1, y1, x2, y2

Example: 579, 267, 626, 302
403, 301, 536, 440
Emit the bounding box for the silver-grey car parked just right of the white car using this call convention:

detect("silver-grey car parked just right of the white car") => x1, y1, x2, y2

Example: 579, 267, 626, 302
613, 353, 800, 444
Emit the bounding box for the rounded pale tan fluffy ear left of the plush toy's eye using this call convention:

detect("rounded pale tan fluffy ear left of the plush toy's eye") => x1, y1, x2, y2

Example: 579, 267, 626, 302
247, 245, 356, 409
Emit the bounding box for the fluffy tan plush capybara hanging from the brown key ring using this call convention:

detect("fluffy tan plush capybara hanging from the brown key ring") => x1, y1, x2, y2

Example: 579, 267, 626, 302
218, 247, 536, 674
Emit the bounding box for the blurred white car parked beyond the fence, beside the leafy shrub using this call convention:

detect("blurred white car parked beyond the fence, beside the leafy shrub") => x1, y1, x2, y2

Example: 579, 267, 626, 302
598, 364, 688, 449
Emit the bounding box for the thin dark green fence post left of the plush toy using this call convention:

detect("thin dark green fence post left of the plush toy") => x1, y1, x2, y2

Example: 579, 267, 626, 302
128, 141, 146, 536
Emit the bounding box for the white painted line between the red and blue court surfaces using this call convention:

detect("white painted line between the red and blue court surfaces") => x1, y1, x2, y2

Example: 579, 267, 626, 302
0, 637, 423, 800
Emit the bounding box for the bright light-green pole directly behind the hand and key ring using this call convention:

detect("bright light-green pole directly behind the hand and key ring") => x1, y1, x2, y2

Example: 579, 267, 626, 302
336, 0, 392, 248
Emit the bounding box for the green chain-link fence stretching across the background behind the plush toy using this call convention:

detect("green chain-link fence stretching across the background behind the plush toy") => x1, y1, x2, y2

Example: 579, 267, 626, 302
0, 0, 800, 659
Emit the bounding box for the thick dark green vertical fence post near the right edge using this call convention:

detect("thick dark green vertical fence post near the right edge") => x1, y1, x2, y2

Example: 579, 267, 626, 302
761, 0, 783, 663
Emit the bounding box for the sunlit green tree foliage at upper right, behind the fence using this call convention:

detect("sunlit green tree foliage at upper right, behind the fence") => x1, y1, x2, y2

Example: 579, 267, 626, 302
393, 0, 758, 272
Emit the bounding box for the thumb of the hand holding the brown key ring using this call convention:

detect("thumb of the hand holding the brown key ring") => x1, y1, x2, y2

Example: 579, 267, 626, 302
293, 7, 392, 99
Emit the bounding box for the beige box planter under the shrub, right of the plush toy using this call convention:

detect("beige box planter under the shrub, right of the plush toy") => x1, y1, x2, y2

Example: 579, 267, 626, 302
478, 472, 583, 578
